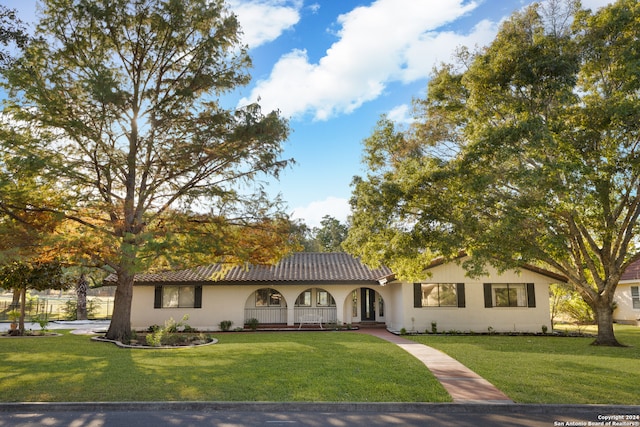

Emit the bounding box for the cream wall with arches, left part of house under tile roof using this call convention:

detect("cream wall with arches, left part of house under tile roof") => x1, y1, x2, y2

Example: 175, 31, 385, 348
131, 283, 390, 331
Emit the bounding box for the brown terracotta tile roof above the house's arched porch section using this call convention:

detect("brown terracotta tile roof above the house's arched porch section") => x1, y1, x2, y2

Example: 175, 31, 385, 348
122, 252, 392, 284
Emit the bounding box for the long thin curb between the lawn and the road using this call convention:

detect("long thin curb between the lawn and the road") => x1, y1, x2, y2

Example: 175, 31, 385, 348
0, 401, 640, 415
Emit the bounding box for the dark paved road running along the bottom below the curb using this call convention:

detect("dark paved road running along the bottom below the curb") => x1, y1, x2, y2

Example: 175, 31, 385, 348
0, 402, 640, 427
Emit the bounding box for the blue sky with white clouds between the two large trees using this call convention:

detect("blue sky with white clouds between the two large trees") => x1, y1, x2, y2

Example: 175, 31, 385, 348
0, 0, 610, 226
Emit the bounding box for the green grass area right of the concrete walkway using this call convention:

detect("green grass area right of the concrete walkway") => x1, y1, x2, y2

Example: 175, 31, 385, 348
408, 325, 640, 405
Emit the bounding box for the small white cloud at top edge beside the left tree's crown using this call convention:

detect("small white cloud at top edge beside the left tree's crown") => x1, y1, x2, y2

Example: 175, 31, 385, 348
229, 0, 302, 48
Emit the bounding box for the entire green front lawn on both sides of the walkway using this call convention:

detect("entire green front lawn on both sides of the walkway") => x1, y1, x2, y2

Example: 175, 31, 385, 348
0, 326, 640, 405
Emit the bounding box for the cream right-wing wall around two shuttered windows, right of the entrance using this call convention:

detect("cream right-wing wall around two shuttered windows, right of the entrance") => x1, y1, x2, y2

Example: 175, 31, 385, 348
388, 263, 554, 332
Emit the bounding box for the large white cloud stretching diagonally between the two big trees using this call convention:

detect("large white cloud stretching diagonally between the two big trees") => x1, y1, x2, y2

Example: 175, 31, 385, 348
241, 0, 497, 120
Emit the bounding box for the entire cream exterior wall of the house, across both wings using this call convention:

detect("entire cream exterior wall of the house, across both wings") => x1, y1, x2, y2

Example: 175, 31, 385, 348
131, 263, 560, 332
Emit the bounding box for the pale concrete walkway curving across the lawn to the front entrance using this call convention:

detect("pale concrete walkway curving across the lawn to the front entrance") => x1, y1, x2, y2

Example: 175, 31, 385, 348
360, 329, 513, 404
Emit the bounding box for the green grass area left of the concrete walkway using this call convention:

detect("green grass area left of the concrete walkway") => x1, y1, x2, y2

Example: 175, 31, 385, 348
0, 332, 450, 402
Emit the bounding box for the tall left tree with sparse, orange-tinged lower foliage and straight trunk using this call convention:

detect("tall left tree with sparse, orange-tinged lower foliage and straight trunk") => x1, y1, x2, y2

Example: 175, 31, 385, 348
4, 0, 290, 340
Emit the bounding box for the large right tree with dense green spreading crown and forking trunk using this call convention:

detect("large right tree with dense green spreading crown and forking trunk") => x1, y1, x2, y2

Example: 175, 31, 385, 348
346, 0, 640, 345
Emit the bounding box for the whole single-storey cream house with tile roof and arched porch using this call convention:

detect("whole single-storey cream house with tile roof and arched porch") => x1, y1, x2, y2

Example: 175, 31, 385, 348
122, 253, 564, 332
